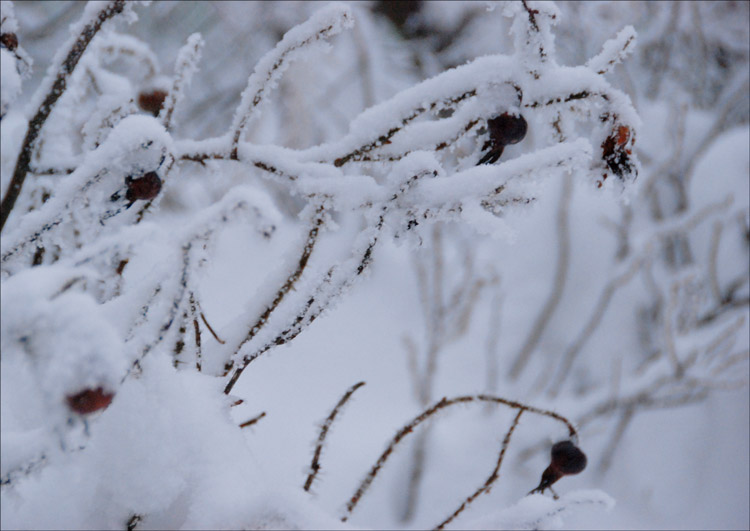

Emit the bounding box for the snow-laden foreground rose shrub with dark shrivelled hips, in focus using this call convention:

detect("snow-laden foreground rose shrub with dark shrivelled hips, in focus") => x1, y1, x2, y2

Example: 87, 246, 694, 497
0, 0, 742, 529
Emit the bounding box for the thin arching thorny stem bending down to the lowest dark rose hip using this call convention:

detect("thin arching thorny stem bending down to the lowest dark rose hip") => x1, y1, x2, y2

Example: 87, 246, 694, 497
341, 395, 578, 522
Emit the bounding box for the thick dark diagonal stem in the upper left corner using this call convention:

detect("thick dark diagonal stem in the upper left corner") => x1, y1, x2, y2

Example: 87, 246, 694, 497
0, 0, 125, 232
